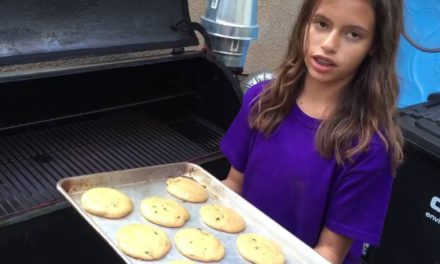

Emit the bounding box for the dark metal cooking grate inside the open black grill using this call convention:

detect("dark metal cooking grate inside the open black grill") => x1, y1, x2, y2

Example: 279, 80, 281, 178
0, 109, 223, 222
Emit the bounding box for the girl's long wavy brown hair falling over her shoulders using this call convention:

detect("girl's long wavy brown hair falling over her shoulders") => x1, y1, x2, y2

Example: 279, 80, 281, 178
249, 0, 403, 174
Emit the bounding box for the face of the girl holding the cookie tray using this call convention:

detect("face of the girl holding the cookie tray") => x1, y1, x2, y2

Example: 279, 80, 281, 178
304, 0, 375, 85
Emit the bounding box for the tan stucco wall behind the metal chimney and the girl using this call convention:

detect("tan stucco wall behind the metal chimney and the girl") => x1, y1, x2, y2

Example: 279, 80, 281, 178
189, 0, 302, 73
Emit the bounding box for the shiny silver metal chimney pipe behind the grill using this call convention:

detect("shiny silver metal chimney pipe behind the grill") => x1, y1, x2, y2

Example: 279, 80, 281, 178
201, 0, 258, 72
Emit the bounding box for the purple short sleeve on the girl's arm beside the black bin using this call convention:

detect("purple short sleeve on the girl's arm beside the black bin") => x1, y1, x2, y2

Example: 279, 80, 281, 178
325, 135, 393, 245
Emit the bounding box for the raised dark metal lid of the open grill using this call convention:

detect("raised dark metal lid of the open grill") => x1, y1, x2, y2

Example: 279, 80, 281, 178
0, 0, 198, 66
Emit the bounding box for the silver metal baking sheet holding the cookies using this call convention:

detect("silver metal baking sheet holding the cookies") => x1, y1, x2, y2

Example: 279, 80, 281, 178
57, 162, 329, 264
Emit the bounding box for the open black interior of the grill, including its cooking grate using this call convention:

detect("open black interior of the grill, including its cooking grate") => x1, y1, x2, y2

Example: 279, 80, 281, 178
0, 54, 239, 225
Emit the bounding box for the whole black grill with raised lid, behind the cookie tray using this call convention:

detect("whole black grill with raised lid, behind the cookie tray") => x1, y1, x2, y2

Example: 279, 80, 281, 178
0, 0, 241, 263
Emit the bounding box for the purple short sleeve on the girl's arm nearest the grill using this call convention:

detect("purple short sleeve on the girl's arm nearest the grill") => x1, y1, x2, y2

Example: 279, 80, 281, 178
220, 82, 267, 173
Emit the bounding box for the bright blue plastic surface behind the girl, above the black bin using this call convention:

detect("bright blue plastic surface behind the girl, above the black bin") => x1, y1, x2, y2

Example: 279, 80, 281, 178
398, 0, 440, 107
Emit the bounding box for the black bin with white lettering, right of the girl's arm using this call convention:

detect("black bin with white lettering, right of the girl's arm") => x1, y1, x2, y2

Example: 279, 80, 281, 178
369, 94, 440, 264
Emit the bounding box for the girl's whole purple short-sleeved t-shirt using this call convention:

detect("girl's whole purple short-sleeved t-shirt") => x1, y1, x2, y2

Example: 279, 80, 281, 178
221, 82, 393, 264
